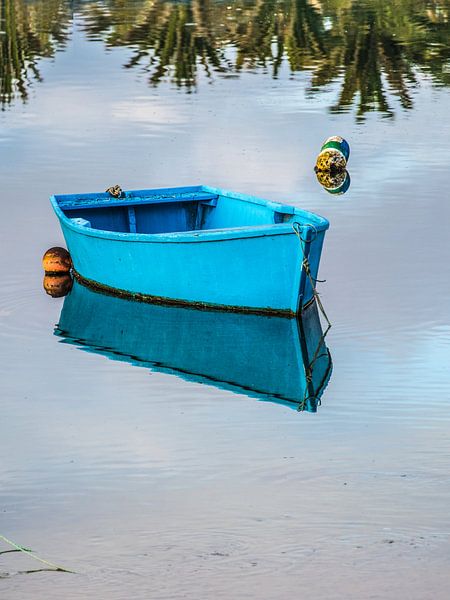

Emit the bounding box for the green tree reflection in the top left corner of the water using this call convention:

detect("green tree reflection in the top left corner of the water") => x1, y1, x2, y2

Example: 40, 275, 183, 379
0, 0, 68, 107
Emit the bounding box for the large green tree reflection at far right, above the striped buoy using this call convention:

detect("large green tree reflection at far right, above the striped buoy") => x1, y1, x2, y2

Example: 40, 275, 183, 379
312, 0, 450, 118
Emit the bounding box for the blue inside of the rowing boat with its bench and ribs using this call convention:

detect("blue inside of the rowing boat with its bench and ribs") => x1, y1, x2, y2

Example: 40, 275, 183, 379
56, 191, 294, 234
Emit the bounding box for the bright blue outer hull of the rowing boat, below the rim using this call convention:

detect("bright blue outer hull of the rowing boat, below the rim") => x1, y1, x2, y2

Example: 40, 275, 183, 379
52, 188, 328, 317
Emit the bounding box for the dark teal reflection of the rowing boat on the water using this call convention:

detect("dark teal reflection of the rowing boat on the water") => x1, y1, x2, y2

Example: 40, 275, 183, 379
55, 281, 332, 412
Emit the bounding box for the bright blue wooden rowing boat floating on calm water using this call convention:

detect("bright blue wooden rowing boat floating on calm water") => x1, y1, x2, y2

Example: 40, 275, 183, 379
51, 186, 329, 317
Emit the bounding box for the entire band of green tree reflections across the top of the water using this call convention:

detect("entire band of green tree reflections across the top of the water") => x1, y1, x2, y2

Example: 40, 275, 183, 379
0, 0, 450, 120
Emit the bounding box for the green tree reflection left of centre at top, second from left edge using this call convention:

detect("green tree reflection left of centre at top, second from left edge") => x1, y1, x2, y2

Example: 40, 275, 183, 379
81, 0, 232, 89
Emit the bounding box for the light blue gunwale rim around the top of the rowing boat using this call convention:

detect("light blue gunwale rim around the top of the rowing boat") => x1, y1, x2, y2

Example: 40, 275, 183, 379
50, 186, 329, 243
